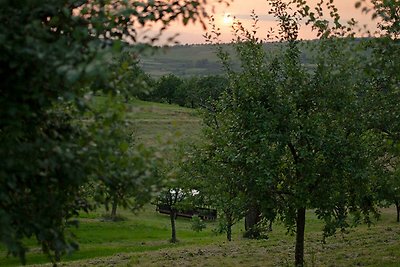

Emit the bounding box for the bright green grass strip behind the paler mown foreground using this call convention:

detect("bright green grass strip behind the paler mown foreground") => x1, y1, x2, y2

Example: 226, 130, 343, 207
0, 204, 228, 266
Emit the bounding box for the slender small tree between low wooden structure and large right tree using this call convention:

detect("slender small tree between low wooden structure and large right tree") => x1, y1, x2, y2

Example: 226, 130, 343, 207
187, 134, 245, 241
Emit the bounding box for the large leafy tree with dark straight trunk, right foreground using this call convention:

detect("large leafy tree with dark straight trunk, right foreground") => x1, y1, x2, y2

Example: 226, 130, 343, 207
203, 0, 384, 266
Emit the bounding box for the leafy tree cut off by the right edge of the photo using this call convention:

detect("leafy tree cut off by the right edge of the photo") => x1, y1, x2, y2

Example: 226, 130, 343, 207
356, 1, 400, 222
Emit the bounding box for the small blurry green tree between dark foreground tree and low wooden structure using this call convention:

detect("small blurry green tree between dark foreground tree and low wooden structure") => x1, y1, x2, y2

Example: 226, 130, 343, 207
88, 97, 162, 220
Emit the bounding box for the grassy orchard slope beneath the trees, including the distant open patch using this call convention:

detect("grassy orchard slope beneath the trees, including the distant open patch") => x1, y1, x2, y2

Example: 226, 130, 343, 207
0, 101, 400, 266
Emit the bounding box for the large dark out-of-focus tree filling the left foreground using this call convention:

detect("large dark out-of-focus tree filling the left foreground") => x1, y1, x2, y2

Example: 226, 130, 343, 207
0, 0, 225, 263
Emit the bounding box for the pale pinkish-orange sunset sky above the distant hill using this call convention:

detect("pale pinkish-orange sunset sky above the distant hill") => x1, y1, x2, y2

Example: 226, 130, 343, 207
148, 0, 372, 44
